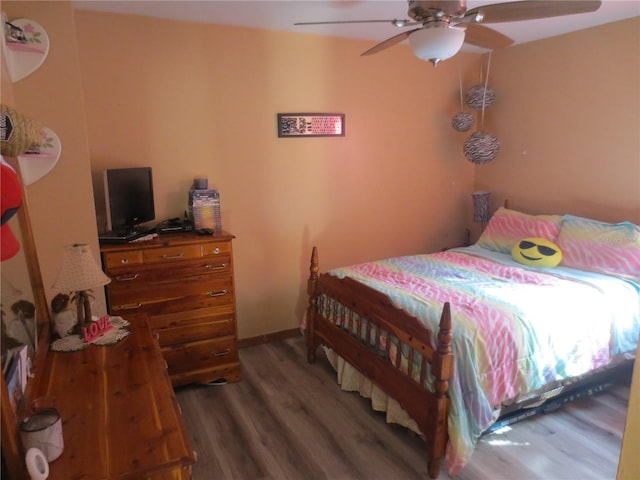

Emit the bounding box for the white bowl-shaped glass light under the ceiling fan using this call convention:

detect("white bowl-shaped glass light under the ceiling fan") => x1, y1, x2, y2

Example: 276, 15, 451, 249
409, 23, 464, 65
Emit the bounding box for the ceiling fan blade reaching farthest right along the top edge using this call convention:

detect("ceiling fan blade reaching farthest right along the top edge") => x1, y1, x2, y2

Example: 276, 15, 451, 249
464, 0, 602, 23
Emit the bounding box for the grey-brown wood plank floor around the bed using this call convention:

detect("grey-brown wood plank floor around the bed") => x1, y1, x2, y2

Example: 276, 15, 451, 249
176, 337, 629, 480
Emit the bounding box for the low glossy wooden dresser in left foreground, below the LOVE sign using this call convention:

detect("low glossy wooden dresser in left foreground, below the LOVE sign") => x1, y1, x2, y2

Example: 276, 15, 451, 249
38, 316, 195, 480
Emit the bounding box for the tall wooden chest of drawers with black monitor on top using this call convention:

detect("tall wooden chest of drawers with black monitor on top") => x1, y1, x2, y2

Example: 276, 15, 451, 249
100, 231, 240, 386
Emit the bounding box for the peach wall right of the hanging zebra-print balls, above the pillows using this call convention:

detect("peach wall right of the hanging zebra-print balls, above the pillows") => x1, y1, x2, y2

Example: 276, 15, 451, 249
476, 17, 640, 223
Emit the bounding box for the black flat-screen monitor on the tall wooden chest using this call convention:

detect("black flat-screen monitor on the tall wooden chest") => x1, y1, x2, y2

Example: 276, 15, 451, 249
104, 167, 156, 237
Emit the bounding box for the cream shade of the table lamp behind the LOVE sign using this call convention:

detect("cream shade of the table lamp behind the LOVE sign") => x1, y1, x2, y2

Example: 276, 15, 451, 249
53, 243, 111, 292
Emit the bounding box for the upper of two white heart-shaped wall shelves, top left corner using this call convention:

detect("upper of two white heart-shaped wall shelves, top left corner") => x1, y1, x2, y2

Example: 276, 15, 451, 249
2, 15, 49, 82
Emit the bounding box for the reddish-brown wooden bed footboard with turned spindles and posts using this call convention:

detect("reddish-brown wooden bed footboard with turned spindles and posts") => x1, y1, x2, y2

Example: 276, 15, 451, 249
306, 247, 453, 478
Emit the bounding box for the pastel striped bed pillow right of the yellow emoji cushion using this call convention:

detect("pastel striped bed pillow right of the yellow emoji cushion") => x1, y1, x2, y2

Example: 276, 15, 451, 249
557, 215, 640, 281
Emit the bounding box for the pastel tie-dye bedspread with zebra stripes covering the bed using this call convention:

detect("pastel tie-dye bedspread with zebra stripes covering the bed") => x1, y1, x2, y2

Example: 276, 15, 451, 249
330, 246, 640, 475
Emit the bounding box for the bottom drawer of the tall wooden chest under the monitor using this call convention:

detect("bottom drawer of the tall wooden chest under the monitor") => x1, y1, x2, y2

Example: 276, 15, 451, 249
162, 336, 238, 375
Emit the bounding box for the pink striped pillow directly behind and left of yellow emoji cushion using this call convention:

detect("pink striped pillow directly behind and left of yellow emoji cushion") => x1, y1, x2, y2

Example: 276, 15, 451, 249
476, 207, 562, 254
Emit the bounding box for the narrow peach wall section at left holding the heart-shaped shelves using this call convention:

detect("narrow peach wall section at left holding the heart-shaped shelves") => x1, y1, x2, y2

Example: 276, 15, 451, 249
1, 1, 106, 314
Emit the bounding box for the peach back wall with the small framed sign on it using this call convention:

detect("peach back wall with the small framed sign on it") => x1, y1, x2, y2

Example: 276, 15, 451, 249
76, 11, 479, 338
